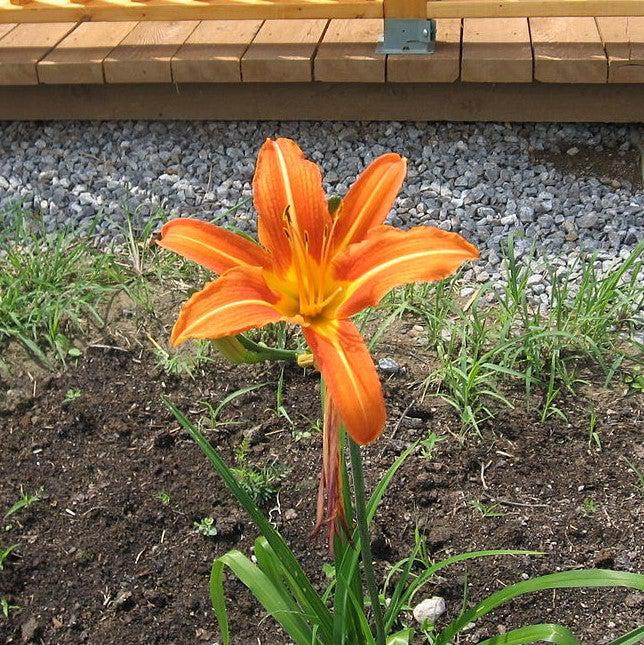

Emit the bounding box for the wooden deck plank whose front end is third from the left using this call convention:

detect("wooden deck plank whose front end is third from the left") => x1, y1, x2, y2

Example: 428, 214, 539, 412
103, 21, 198, 83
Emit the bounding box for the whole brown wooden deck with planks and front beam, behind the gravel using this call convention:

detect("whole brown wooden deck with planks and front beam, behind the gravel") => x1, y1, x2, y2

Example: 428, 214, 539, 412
0, 17, 644, 122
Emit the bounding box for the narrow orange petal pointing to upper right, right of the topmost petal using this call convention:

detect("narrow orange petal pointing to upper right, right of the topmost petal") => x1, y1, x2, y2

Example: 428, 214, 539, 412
333, 152, 407, 250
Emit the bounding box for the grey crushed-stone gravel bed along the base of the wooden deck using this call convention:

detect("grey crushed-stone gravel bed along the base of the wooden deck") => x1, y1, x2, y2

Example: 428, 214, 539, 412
0, 121, 644, 300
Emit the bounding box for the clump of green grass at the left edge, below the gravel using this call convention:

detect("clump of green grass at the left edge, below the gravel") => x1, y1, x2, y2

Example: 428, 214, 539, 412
0, 211, 126, 367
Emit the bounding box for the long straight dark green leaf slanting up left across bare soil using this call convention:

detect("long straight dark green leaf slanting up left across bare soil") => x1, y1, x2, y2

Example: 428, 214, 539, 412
163, 397, 332, 642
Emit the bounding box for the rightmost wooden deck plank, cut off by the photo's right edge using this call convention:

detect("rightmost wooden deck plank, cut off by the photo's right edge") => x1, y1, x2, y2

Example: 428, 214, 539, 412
597, 17, 644, 83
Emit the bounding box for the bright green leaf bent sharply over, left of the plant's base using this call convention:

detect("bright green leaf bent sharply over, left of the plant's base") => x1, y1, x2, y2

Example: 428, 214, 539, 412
210, 549, 313, 645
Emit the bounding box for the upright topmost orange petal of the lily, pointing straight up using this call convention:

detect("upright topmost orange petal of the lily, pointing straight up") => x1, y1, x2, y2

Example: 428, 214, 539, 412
253, 139, 331, 273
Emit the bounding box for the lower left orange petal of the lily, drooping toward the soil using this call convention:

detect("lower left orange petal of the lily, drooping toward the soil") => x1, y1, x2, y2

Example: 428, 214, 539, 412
170, 267, 284, 346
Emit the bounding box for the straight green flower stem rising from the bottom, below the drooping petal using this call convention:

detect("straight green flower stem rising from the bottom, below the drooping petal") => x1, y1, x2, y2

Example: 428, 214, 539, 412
348, 438, 385, 645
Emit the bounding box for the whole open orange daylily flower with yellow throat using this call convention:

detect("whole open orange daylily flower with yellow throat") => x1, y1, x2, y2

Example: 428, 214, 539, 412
159, 139, 479, 536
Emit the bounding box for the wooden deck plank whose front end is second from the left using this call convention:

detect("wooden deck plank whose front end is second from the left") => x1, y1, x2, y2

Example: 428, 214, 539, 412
37, 22, 136, 84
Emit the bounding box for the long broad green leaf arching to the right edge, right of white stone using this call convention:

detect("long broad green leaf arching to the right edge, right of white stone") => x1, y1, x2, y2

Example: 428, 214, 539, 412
436, 569, 644, 645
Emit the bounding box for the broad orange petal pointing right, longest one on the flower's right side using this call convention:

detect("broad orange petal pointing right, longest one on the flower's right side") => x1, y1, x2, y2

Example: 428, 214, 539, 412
335, 226, 479, 318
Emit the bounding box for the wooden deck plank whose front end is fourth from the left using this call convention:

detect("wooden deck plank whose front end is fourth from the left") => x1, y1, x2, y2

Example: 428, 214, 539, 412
172, 20, 262, 83
